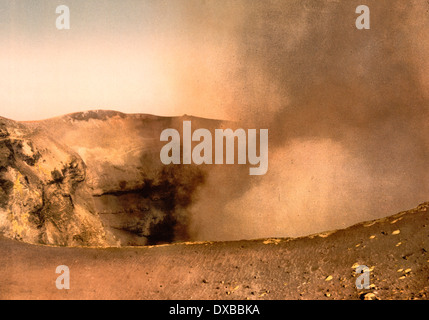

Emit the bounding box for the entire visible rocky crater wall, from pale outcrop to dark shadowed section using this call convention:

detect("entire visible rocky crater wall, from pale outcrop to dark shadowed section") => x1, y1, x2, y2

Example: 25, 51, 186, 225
0, 111, 218, 246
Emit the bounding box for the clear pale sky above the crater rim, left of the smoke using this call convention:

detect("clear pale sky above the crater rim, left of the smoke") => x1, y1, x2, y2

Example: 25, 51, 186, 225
0, 0, 244, 120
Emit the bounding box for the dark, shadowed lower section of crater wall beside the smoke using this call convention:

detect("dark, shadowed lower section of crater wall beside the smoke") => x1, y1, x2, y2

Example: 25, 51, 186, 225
94, 167, 204, 245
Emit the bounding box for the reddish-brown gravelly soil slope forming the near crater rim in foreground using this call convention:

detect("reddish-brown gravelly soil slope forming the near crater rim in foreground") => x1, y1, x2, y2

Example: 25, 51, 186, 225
0, 204, 429, 299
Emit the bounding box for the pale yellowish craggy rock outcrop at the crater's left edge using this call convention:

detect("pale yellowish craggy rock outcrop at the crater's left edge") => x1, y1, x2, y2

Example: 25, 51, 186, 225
0, 119, 116, 246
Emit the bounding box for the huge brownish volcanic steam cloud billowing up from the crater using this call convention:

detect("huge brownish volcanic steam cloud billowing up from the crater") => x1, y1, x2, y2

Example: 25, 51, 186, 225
182, 0, 429, 240
